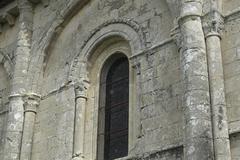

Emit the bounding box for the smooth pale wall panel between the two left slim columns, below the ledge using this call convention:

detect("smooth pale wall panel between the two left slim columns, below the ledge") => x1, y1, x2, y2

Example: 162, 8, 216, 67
32, 87, 75, 160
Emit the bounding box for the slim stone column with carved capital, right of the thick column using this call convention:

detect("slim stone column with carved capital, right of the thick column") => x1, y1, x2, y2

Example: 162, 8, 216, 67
204, 10, 231, 160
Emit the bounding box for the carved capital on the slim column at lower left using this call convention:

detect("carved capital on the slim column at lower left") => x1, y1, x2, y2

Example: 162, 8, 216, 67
23, 94, 41, 113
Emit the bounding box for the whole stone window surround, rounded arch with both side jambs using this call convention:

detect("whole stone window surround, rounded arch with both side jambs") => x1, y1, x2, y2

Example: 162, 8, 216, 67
66, 19, 146, 159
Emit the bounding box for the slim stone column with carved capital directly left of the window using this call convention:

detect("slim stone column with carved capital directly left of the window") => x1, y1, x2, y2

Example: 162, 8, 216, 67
73, 80, 88, 160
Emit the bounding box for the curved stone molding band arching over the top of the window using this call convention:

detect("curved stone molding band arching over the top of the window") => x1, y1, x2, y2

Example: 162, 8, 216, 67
69, 18, 147, 81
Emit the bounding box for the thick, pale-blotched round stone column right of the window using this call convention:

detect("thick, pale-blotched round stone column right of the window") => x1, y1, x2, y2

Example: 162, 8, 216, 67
172, 0, 214, 160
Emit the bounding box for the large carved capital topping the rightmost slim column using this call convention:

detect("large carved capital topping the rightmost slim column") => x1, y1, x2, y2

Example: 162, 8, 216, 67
202, 10, 224, 38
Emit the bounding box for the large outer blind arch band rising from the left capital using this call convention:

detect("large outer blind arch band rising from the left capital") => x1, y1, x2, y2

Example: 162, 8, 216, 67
29, 0, 176, 92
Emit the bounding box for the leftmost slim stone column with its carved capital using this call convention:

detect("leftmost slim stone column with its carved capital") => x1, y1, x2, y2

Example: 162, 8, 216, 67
20, 94, 40, 160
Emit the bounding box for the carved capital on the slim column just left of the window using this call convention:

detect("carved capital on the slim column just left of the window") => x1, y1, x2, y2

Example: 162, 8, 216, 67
74, 80, 89, 99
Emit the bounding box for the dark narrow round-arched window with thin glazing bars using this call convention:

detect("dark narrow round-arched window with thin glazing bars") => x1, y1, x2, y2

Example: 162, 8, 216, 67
98, 54, 129, 160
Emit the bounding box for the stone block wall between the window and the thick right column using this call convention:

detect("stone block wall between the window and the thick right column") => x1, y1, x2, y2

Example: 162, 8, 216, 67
136, 42, 183, 154
